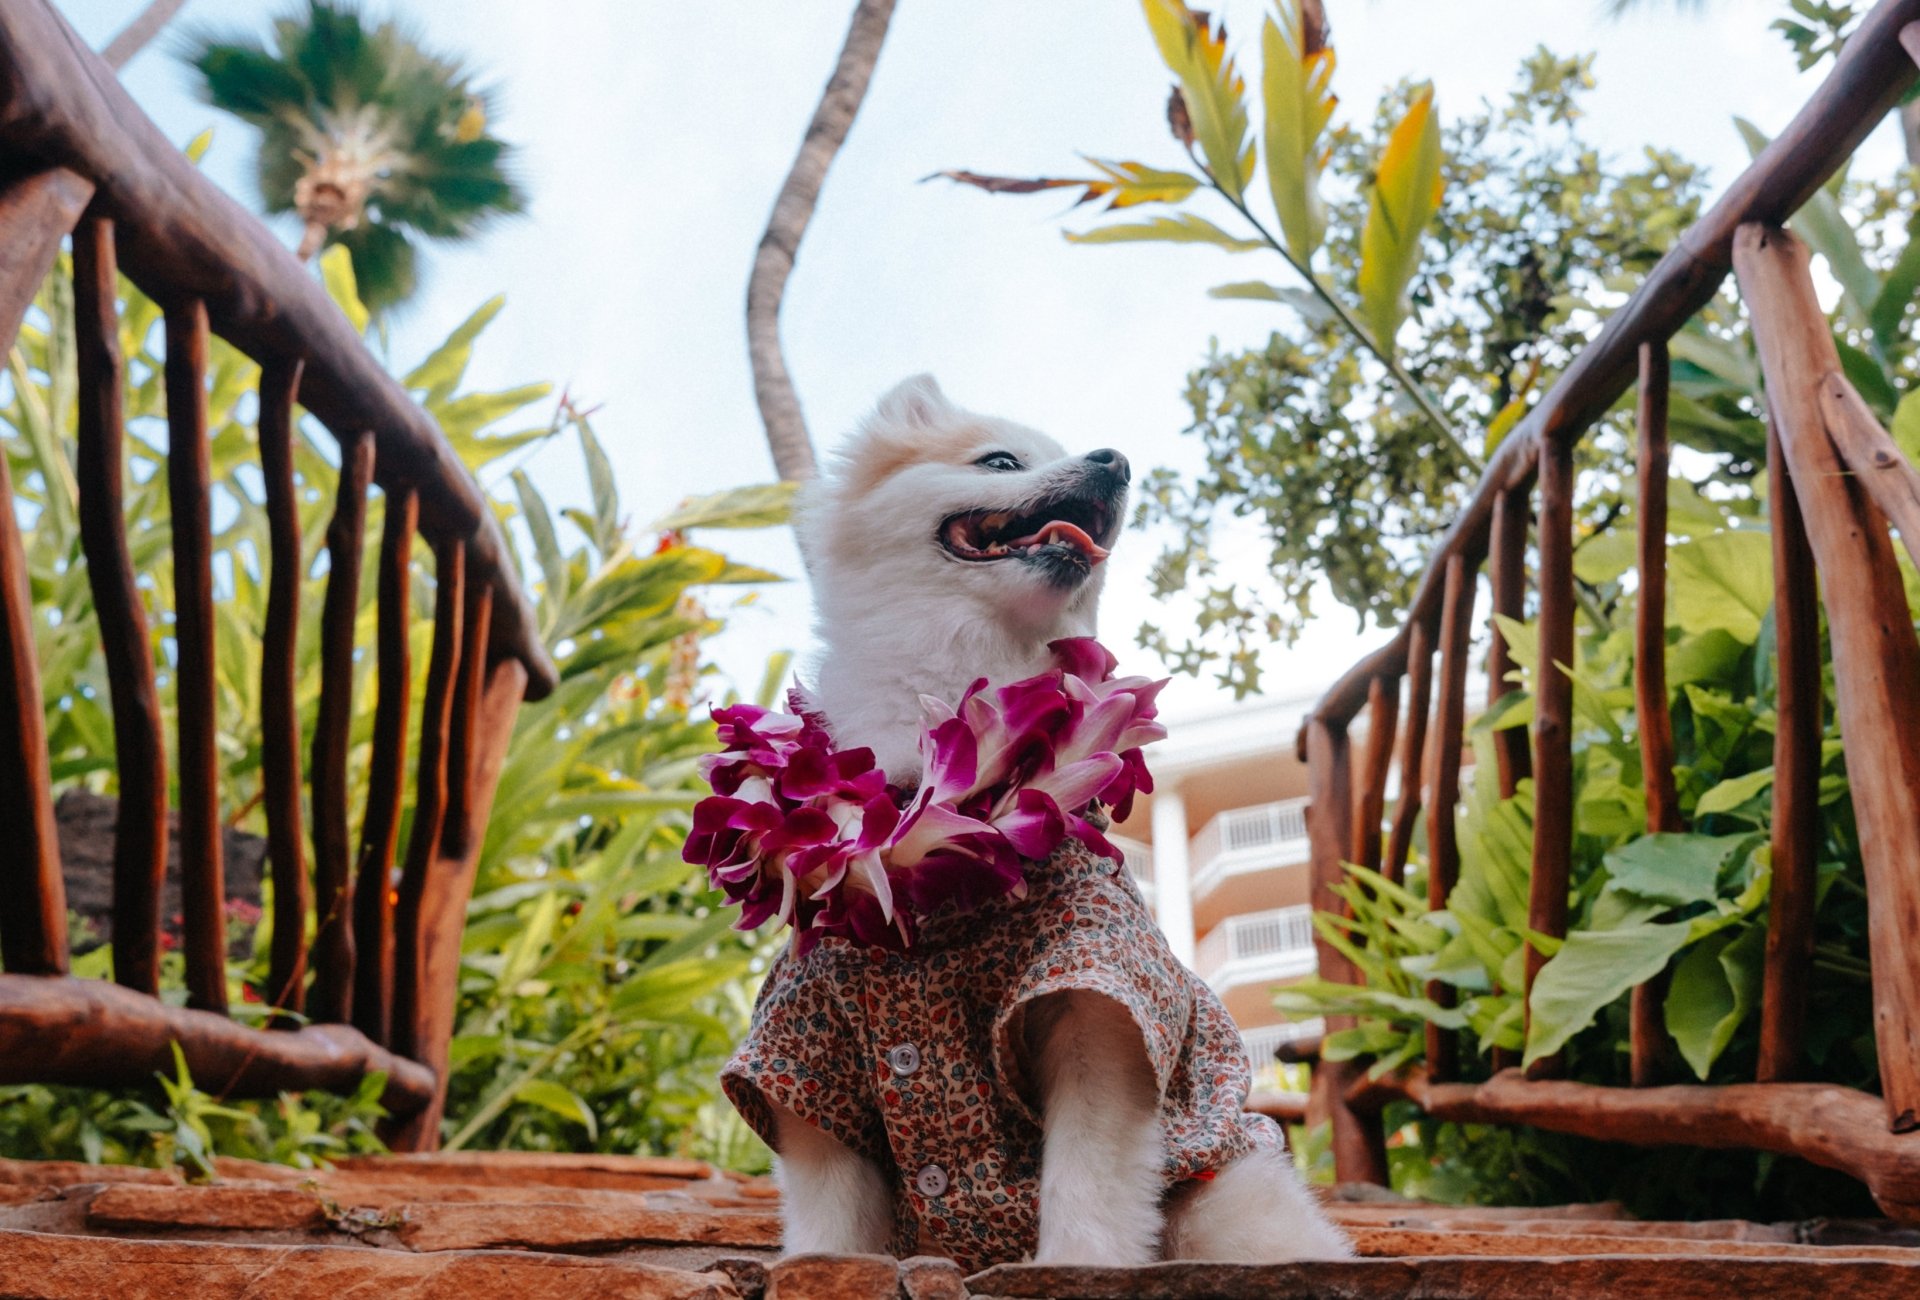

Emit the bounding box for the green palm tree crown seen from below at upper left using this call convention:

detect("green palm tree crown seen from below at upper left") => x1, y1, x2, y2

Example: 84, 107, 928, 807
186, 0, 526, 311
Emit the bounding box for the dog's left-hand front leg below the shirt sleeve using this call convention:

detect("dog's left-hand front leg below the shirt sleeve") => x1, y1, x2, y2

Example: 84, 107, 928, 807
774, 1108, 893, 1254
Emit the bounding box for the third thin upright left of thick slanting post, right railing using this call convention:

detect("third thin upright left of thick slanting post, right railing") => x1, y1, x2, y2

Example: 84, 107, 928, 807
1526, 438, 1574, 1075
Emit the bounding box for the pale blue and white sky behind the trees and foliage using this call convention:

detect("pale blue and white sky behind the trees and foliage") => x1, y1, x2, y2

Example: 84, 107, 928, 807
54, 0, 1897, 714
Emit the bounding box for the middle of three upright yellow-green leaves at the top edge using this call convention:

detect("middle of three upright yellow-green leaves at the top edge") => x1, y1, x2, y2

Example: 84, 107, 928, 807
1261, 0, 1338, 267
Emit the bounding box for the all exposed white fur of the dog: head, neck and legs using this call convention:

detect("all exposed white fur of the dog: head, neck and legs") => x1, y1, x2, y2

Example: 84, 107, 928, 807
778, 376, 1352, 1265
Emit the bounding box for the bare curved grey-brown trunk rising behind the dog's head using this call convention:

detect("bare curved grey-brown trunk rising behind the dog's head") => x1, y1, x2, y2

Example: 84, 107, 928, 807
747, 0, 895, 480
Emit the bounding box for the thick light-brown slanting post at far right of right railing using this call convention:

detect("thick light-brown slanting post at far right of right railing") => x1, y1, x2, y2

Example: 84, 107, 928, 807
1734, 225, 1920, 1133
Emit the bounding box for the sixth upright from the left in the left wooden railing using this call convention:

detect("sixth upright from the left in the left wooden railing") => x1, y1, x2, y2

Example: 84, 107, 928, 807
351, 488, 420, 1043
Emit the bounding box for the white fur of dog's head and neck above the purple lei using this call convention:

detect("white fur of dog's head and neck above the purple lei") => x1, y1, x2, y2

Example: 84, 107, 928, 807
795, 374, 1106, 783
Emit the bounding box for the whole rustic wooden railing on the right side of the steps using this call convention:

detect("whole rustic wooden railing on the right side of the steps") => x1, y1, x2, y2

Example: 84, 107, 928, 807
1300, 0, 1920, 1219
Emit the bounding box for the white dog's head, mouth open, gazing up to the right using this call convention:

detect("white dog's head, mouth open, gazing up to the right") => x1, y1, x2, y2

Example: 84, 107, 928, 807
799, 374, 1129, 636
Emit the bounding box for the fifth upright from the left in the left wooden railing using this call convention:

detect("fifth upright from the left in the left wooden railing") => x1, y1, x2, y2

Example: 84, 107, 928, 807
311, 432, 378, 1022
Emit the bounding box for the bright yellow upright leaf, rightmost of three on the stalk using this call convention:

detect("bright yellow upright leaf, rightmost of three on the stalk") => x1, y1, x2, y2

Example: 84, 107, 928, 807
1359, 84, 1442, 353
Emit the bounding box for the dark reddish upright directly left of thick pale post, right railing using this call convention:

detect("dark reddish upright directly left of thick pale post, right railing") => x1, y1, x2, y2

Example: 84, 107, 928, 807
1755, 410, 1832, 1083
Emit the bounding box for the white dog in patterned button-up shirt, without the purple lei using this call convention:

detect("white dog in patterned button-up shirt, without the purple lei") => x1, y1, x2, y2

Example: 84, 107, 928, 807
724, 376, 1350, 1265
